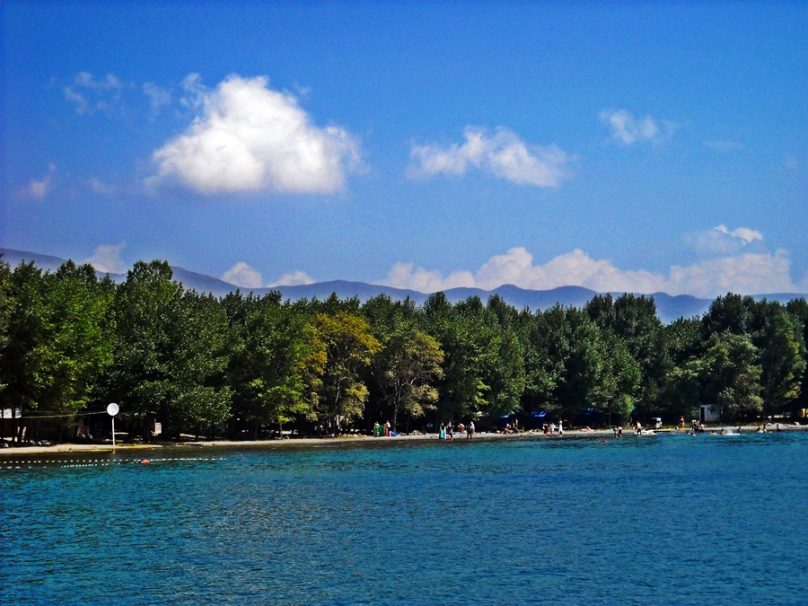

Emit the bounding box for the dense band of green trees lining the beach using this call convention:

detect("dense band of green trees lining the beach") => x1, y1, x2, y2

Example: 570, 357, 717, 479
0, 260, 808, 442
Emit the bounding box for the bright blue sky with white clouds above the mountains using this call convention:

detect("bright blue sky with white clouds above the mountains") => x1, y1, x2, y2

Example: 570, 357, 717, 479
0, 1, 808, 296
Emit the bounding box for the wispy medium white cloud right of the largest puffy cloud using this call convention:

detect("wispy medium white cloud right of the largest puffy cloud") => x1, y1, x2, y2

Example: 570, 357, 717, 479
409, 126, 572, 187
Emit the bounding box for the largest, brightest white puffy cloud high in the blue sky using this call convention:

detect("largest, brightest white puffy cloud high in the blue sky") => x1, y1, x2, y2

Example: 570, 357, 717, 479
147, 74, 359, 194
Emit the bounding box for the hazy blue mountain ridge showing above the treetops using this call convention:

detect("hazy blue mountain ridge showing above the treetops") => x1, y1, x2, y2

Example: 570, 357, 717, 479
0, 248, 808, 322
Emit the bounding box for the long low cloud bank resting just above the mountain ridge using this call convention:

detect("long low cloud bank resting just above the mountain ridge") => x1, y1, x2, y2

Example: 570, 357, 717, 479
384, 247, 796, 297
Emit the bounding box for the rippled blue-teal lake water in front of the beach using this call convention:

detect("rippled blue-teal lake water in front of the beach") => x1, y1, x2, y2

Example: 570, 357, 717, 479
0, 432, 808, 605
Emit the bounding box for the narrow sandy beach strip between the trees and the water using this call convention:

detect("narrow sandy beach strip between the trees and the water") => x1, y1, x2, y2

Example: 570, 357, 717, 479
0, 423, 808, 459
